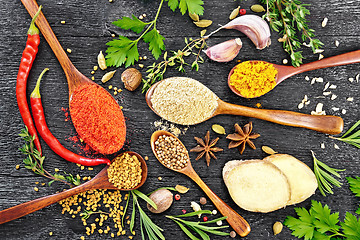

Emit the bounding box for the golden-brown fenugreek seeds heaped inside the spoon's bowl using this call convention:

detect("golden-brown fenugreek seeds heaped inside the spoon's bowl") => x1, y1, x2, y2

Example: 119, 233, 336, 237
107, 153, 142, 189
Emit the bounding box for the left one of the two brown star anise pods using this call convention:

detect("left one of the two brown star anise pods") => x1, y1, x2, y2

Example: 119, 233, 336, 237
190, 131, 223, 166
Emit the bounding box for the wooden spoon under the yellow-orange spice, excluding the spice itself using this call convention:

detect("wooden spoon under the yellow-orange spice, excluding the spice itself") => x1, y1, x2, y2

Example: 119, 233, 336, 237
228, 50, 360, 98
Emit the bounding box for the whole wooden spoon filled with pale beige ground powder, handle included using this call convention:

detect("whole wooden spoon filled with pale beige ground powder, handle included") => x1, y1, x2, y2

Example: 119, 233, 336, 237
146, 77, 344, 134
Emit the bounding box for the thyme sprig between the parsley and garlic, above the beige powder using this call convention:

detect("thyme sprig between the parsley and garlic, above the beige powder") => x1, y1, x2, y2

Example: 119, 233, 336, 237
142, 35, 206, 92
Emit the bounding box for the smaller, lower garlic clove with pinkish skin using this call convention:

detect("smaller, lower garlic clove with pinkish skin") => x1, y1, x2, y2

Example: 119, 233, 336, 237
204, 38, 242, 62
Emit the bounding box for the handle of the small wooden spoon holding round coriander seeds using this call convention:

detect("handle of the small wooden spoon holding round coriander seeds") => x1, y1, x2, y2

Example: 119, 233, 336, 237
186, 170, 251, 237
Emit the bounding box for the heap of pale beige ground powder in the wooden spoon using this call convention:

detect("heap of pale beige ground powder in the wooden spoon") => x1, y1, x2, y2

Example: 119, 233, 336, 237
151, 77, 218, 125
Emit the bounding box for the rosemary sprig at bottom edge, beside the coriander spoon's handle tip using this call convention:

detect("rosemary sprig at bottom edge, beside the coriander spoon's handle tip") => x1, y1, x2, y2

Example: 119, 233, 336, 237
166, 210, 230, 240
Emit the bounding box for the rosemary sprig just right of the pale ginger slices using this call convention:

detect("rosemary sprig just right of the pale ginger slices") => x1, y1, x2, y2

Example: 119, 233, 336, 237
311, 151, 345, 196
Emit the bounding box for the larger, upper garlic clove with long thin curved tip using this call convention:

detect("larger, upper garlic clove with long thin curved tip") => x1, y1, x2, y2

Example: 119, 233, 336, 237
204, 14, 271, 49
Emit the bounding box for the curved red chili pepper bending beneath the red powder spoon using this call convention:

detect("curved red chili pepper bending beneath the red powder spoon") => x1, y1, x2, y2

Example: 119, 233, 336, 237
30, 68, 110, 166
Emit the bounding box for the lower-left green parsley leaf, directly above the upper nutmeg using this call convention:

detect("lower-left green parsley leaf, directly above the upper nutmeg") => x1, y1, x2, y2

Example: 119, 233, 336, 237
106, 36, 139, 67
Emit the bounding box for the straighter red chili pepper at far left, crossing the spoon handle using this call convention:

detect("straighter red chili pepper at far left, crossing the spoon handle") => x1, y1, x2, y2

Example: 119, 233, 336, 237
16, 6, 42, 155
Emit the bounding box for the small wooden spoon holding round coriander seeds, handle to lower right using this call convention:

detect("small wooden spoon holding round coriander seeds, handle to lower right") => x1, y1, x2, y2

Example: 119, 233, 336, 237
150, 130, 251, 237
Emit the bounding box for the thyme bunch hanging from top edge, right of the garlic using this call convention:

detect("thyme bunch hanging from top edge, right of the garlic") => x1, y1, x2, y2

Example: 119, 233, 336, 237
259, 0, 324, 67
